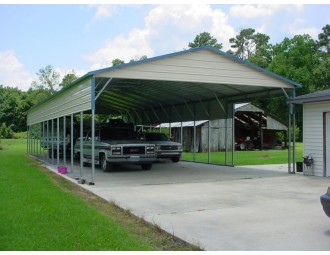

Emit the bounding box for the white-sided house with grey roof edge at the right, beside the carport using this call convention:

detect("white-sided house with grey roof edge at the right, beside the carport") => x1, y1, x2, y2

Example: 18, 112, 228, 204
287, 89, 330, 177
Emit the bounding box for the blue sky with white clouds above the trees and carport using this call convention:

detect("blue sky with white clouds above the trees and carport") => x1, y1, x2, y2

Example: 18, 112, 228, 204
0, 0, 330, 91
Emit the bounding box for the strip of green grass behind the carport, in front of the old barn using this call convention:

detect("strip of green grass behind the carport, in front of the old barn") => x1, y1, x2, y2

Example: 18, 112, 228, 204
182, 143, 303, 166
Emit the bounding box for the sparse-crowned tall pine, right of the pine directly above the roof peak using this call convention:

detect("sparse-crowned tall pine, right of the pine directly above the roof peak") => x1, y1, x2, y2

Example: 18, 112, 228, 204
229, 28, 270, 59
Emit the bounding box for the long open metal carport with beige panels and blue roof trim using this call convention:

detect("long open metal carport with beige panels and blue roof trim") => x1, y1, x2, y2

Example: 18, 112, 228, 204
27, 46, 301, 184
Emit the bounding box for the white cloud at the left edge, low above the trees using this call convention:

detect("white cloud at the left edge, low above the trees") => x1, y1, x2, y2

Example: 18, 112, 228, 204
0, 50, 36, 91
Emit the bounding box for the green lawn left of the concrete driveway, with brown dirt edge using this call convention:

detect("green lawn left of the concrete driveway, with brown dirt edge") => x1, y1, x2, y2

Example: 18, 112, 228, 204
0, 140, 198, 251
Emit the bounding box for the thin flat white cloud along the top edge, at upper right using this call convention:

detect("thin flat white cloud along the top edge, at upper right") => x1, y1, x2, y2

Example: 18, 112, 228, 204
229, 4, 303, 19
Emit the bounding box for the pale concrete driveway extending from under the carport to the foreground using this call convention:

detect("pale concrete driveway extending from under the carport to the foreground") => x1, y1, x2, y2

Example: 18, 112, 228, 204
57, 161, 330, 251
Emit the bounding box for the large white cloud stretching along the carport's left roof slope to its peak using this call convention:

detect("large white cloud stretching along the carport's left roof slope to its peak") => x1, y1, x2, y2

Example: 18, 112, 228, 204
84, 5, 235, 69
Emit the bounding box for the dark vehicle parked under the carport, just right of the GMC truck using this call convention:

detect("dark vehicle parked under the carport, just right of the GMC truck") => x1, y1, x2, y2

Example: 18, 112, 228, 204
139, 132, 182, 163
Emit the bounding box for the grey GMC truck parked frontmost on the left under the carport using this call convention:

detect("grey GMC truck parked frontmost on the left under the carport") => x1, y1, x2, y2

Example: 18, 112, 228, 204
74, 123, 157, 172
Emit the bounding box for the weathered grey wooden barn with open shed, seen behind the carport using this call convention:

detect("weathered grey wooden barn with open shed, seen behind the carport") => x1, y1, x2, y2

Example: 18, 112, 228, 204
160, 103, 288, 152
